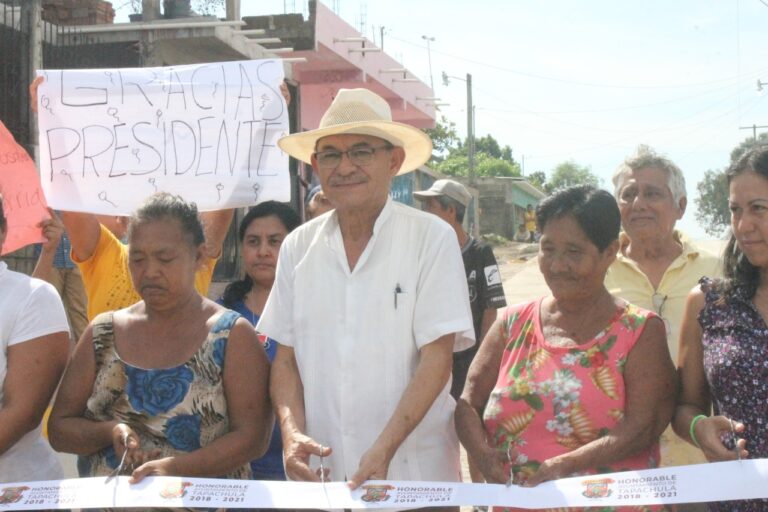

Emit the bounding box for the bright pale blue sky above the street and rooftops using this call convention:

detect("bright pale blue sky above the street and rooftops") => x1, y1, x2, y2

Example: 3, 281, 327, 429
115, 0, 768, 237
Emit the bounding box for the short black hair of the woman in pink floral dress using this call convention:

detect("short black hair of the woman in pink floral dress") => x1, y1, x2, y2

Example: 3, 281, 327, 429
536, 185, 621, 252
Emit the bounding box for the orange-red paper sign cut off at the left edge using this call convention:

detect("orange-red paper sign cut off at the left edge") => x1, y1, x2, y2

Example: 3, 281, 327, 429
0, 121, 50, 254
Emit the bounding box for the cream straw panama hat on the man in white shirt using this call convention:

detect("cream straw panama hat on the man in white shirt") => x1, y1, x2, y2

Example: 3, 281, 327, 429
277, 89, 432, 174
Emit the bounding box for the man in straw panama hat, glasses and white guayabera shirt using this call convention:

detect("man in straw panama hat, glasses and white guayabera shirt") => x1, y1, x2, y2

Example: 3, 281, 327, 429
257, 89, 474, 496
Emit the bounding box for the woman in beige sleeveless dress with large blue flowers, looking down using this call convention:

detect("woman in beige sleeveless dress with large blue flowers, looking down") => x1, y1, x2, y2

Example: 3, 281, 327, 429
49, 194, 272, 483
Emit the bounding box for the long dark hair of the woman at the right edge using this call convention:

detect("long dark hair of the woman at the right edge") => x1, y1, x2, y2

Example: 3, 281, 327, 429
717, 145, 768, 298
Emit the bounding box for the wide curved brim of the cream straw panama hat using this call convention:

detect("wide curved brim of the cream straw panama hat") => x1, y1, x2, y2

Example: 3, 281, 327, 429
277, 121, 432, 174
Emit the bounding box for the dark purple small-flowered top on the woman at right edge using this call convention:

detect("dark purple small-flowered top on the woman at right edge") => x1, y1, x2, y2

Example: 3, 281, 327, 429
699, 278, 768, 512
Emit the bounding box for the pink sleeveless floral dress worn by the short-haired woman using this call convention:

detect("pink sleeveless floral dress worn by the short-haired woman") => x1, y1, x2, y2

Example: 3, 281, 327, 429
483, 299, 662, 511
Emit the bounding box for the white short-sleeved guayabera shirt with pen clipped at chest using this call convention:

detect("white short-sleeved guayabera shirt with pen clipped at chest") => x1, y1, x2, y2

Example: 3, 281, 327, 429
257, 199, 474, 481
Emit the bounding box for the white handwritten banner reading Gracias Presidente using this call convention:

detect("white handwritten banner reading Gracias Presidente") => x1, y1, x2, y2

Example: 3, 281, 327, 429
38, 60, 290, 215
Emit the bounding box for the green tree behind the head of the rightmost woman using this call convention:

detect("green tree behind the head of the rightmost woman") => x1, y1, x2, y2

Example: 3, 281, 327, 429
696, 133, 768, 236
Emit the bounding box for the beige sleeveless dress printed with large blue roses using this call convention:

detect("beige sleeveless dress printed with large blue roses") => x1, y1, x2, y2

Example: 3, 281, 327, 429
78, 311, 251, 479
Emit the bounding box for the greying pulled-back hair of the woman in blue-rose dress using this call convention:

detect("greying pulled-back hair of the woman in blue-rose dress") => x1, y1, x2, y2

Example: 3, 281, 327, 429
128, 192, 205, 247
